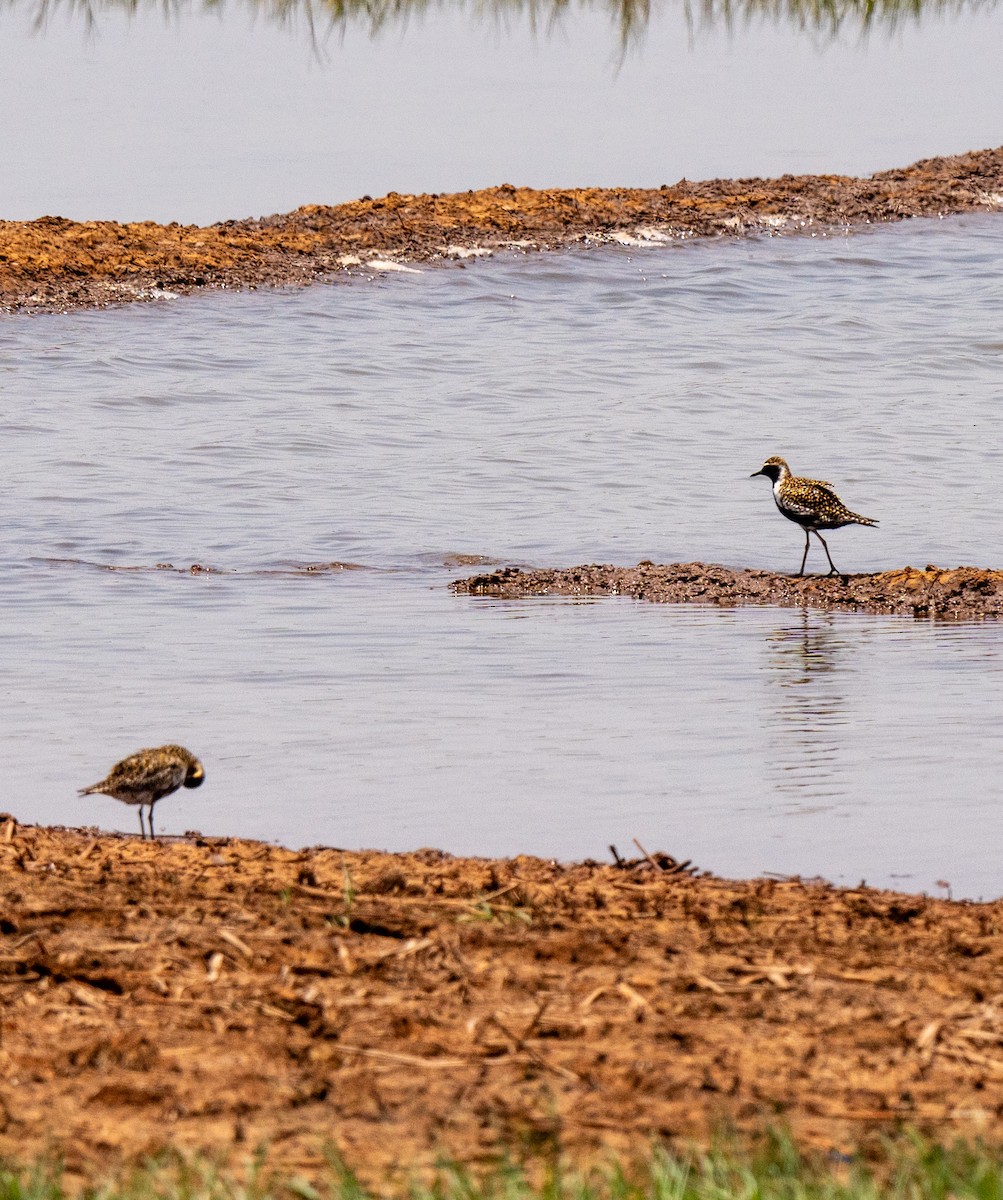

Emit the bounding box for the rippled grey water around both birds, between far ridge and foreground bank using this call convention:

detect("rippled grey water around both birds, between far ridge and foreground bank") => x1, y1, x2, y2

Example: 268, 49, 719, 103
0, 216, 1003, 895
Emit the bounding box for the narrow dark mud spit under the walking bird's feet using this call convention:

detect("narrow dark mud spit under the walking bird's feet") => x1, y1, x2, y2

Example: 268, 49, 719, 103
450, 562, 1003, 619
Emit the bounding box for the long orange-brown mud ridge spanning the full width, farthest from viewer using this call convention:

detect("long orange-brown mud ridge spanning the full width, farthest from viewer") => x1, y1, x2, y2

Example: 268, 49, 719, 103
0, 148, 1003, 312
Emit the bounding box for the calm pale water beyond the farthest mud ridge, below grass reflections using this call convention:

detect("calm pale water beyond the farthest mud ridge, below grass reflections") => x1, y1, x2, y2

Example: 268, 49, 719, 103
0, 0, 1003, 223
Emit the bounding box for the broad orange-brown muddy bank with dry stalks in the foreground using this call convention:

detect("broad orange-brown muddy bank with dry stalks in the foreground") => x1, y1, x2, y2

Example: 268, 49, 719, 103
0, 825, 1003, 1180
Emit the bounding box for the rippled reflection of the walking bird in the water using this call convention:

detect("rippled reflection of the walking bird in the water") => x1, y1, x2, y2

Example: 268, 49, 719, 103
767, 608, 860, 812
